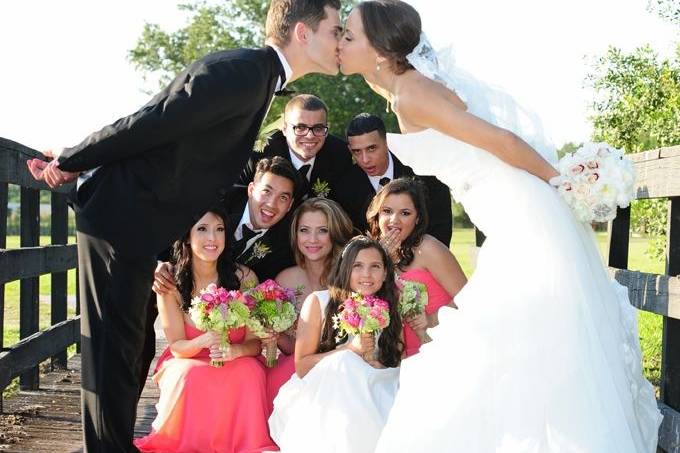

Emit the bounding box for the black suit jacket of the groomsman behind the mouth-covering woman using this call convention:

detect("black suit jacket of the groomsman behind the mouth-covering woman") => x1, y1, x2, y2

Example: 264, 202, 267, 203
338, 154, 453, 246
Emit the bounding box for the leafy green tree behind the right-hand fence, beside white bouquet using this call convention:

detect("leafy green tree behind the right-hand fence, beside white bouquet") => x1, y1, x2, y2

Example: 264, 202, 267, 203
588, 43, 680, 258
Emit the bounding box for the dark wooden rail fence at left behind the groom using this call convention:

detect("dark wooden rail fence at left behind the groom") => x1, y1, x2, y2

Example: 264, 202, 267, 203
0, 138, 80, 411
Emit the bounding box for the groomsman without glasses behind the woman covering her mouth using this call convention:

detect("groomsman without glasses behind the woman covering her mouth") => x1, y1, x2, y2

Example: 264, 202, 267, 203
338, 113, 453, 246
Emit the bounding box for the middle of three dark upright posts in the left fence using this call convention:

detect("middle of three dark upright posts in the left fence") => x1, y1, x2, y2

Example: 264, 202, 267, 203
19, 187, 40, 390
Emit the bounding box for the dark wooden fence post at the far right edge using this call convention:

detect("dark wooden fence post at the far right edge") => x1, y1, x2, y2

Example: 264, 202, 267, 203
661, 197, 680, 410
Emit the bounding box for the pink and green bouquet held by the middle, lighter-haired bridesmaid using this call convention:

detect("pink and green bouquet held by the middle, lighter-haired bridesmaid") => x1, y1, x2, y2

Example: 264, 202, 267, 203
246, 280, 297, 368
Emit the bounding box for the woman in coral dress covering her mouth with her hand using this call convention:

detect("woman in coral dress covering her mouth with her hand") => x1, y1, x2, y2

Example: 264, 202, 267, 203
366, 178, 467, 357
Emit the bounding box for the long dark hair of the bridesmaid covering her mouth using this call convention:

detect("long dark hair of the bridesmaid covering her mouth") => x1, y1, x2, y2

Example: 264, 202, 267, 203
366, 178, 430, 272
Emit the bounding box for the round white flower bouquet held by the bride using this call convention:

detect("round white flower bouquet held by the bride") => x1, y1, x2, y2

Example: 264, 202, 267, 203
550, 143, 635, 223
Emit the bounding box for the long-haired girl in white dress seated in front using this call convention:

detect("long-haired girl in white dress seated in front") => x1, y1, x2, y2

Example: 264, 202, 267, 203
269, 236, 403, 453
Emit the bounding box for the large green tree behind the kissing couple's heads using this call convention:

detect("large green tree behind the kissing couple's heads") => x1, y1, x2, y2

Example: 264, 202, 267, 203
128, 0, 398, 136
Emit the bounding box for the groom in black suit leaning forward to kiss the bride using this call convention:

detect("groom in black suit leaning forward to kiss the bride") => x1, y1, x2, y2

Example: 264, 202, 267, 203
28, 0, 341, 452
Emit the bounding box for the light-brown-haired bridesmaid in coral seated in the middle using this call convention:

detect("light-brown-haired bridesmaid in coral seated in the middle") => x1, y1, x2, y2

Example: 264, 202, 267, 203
267, 198, 352, 407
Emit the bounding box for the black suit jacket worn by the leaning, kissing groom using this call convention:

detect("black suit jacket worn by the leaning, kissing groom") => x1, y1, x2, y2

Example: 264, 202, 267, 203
59, 47, 284, 257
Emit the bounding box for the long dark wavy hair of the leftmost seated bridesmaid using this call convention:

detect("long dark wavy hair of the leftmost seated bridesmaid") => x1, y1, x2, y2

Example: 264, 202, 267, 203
171, 207, 241, 312
